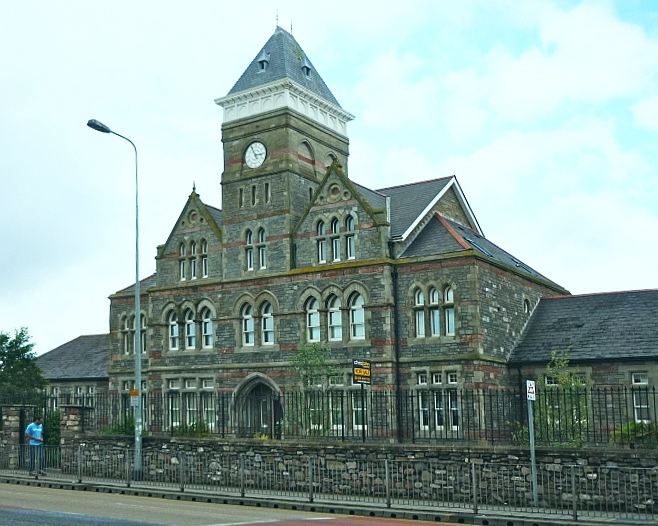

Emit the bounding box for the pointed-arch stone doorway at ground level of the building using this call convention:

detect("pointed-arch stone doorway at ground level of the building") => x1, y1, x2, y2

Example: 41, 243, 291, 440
236, 378, 283, 439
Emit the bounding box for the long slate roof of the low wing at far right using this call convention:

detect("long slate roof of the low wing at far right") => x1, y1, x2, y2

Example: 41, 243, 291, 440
510, 290, 658, 364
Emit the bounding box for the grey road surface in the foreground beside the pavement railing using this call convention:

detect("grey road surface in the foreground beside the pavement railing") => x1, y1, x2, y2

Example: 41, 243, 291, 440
0, 484, 462, 526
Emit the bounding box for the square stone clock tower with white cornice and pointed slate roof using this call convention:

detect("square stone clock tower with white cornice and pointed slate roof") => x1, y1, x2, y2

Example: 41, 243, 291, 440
215, 27, 353, 279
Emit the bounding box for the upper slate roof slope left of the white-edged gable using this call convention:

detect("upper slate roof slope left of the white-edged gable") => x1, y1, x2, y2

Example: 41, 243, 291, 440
376, 177, 452, 238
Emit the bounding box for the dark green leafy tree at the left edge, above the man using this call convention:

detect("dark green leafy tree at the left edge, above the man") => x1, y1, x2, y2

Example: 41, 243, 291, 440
0, 327, 48, 396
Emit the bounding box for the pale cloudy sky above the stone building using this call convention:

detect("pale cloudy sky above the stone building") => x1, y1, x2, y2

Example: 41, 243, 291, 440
0, 0, 658, 354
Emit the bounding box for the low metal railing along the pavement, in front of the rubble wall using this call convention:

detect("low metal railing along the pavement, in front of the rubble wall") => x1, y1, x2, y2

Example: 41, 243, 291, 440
0, 446, 658, 521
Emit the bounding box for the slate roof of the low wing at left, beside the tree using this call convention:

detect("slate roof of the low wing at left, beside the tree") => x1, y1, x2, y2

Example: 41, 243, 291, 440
37, 334, 110, 380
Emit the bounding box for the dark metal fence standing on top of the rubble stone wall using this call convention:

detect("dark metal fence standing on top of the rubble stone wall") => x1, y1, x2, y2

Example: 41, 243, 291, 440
0, 386, 658, 448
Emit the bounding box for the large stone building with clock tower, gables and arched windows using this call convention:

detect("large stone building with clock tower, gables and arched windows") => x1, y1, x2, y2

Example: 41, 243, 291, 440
37, 28, 658, 442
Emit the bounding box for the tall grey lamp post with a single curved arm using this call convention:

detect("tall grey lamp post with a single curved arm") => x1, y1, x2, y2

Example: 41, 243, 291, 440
87, 119, 142, 480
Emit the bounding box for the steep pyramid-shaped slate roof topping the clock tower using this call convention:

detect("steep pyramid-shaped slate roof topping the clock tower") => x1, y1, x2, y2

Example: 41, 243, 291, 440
228, 27, 340, 108
